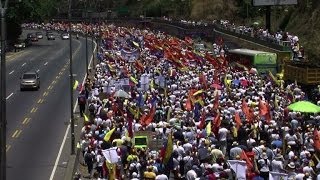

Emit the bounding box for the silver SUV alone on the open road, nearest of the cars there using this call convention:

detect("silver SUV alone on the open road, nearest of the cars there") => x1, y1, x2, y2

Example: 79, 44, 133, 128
20, 71, 40, 91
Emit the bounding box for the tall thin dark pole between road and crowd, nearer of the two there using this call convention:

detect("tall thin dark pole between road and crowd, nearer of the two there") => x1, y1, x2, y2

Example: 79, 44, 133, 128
68, 0, 75, 155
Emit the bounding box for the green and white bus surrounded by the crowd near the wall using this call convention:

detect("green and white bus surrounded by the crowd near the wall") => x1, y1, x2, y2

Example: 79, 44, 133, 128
227, 49, 277, 74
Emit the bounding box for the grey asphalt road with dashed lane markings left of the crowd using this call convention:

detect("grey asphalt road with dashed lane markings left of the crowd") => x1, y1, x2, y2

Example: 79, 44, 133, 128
6, 29, 92, 180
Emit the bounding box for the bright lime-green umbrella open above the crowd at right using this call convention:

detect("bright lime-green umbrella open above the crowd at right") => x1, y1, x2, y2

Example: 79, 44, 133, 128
288, 101, 320, 113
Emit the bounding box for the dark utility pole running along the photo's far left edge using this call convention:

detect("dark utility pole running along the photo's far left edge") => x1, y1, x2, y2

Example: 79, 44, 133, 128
0, 0, 8, 180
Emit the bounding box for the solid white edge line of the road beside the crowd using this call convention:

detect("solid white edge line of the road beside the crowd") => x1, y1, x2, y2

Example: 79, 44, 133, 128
49, 39, 97, 180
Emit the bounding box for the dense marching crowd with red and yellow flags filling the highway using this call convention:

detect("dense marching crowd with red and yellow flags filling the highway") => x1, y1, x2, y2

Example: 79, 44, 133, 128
25, 23, 320, 180
